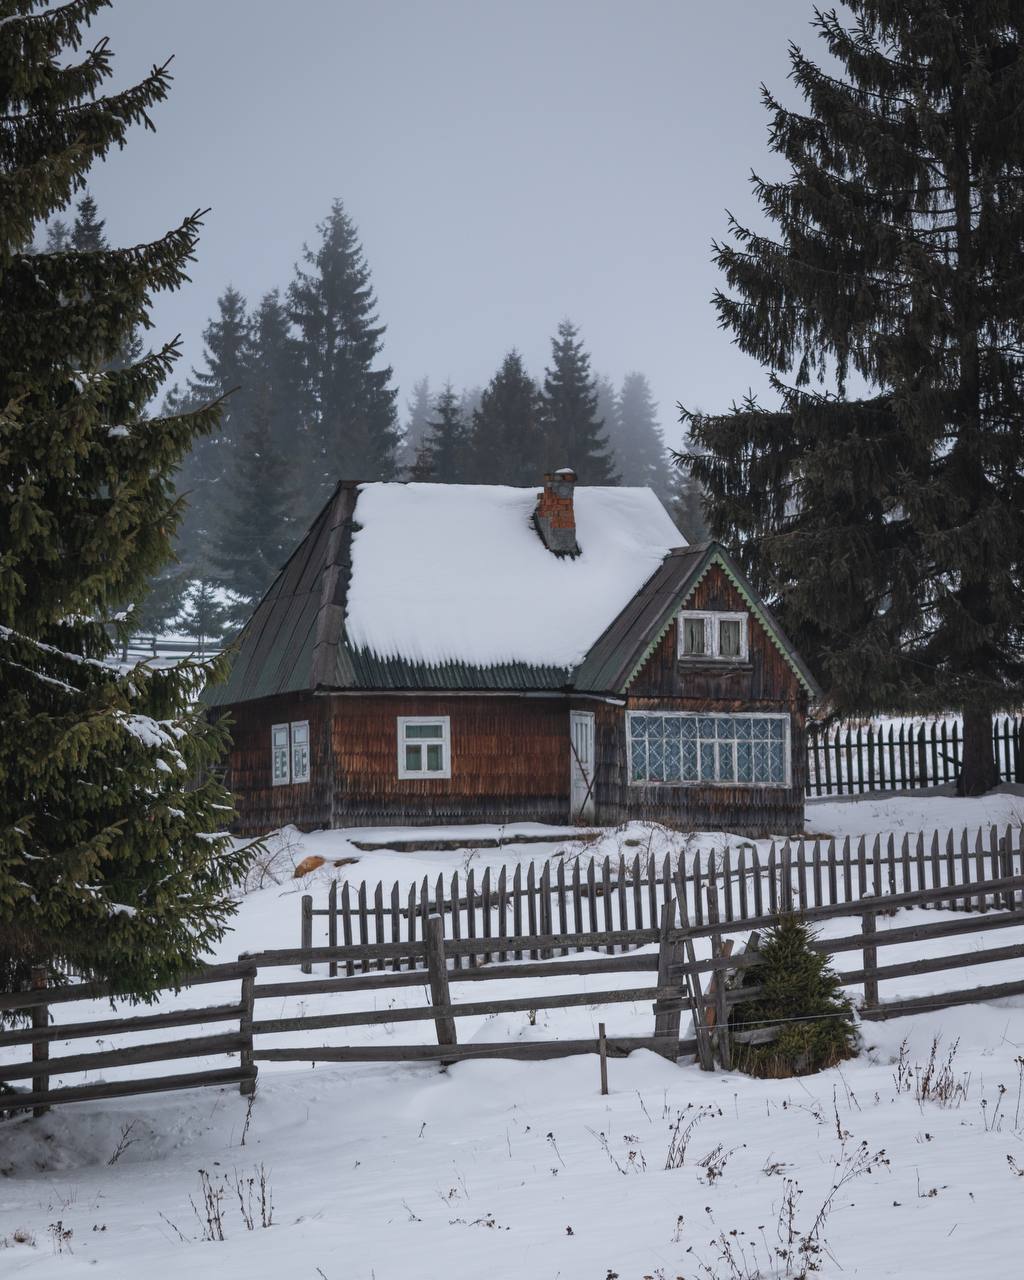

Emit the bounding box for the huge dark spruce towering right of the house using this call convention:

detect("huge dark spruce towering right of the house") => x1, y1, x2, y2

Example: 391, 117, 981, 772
691, 0, 1024, 795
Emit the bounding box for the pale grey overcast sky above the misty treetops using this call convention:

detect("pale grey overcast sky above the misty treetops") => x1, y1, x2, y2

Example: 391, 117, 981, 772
85, 0, 818, 443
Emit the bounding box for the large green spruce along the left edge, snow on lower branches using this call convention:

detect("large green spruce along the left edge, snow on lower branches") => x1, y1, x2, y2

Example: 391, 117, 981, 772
0, 0, 247, 997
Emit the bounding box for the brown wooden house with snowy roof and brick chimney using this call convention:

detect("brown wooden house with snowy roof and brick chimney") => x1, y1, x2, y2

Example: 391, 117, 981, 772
205, 470, 817, 835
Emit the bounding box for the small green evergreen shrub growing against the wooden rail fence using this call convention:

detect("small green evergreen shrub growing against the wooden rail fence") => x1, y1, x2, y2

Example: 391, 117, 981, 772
730, 915, 858, 1078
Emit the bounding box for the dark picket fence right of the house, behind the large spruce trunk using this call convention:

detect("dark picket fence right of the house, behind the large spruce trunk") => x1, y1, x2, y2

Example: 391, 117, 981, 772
806, 716, 1024, 796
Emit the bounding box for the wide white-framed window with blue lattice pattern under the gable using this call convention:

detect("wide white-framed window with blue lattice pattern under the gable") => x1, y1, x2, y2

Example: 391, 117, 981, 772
626, 712, 791, 787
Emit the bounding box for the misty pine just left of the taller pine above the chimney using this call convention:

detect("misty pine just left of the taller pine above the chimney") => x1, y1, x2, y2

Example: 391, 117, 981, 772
470, 349, 547, 485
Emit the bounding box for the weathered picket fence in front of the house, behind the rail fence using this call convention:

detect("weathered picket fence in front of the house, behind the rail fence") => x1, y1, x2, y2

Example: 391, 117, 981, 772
300, 827, 1024, 975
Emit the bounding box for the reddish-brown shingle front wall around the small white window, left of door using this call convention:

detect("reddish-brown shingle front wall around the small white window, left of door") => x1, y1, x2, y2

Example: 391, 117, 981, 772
323, 694, 568, 827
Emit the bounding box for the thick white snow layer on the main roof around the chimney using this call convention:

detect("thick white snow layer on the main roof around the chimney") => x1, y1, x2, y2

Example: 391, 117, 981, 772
344, 483, 685, 668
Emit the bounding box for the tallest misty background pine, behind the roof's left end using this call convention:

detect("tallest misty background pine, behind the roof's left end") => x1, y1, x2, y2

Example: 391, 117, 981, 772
288, 200, 398, 513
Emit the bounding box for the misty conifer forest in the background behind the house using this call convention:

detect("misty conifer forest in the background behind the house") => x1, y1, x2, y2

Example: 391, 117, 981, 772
37, 193, 707, 643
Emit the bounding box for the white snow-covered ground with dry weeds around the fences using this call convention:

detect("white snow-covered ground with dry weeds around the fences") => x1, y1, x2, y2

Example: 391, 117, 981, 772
0, 795, 1024, 1280
